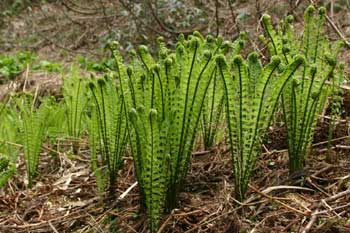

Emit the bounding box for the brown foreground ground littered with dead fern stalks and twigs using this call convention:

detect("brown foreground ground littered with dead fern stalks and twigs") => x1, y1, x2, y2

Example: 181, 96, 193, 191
0, 123, 350, 233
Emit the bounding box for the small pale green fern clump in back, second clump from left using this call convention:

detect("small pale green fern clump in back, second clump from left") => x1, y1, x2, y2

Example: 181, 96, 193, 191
62, 67, 88, 142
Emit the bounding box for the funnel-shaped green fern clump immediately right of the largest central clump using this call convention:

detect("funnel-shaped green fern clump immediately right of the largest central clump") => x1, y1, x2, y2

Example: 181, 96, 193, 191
217, 53, 304, 200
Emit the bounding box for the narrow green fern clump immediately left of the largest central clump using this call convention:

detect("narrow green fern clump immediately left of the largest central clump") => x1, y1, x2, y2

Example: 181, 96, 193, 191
89, 76, 128, 197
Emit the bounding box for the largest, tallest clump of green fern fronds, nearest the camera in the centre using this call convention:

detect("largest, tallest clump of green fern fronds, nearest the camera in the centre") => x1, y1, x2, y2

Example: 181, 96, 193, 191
112, 33, 221, 232
